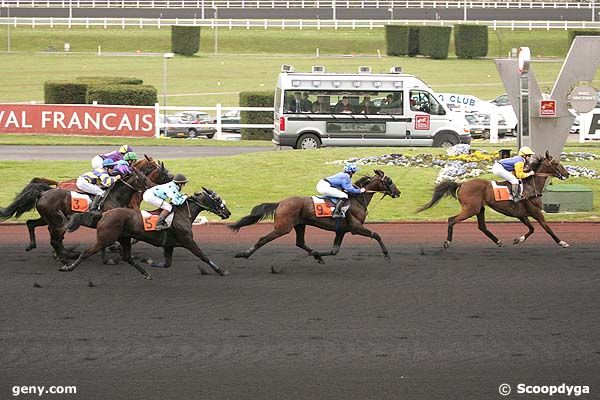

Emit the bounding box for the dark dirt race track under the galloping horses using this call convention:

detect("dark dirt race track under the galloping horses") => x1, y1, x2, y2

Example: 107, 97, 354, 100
0, 224, 600, 400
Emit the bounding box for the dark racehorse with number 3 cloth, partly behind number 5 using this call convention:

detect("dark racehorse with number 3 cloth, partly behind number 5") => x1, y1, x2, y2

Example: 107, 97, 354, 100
0, 169, 153, 261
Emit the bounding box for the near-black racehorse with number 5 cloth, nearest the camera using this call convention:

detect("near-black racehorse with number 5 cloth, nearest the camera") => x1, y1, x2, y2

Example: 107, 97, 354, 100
60, 188, 231, 279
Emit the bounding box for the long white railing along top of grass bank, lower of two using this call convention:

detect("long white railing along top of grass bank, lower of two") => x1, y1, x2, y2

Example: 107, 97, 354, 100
0, 17, 600, 30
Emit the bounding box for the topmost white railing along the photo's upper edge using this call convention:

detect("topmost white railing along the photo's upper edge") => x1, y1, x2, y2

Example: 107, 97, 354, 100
0, 0, 593, 9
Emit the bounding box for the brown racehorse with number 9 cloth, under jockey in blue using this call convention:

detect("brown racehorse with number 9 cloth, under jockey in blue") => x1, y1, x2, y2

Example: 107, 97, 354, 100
229, 170, 400, 264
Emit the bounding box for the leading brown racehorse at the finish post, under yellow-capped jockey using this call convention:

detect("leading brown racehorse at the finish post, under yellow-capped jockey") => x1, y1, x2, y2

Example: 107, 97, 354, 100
417, 152, 569, 248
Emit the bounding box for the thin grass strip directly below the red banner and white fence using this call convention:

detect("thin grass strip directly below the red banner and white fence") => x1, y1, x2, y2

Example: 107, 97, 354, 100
0, 135, 271, 147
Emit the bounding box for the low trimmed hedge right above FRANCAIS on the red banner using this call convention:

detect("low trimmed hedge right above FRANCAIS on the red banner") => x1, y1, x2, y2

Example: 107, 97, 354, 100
87, 85, 158, 106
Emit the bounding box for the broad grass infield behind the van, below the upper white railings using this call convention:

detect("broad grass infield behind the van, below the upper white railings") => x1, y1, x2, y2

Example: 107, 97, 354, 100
0, 28, 600, 106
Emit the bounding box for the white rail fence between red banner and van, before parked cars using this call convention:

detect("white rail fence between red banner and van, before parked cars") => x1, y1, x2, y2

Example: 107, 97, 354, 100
154, 104, 274, 140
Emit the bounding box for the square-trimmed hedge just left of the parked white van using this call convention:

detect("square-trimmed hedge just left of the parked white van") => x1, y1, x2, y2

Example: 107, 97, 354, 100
240, 92, 274, 140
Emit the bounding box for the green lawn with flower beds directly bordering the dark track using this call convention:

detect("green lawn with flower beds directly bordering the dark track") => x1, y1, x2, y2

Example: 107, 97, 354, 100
0, 148, 600, 221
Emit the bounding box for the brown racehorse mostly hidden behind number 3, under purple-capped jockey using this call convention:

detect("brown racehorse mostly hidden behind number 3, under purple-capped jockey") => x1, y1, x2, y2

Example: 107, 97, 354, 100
19, 154, 173, 251
